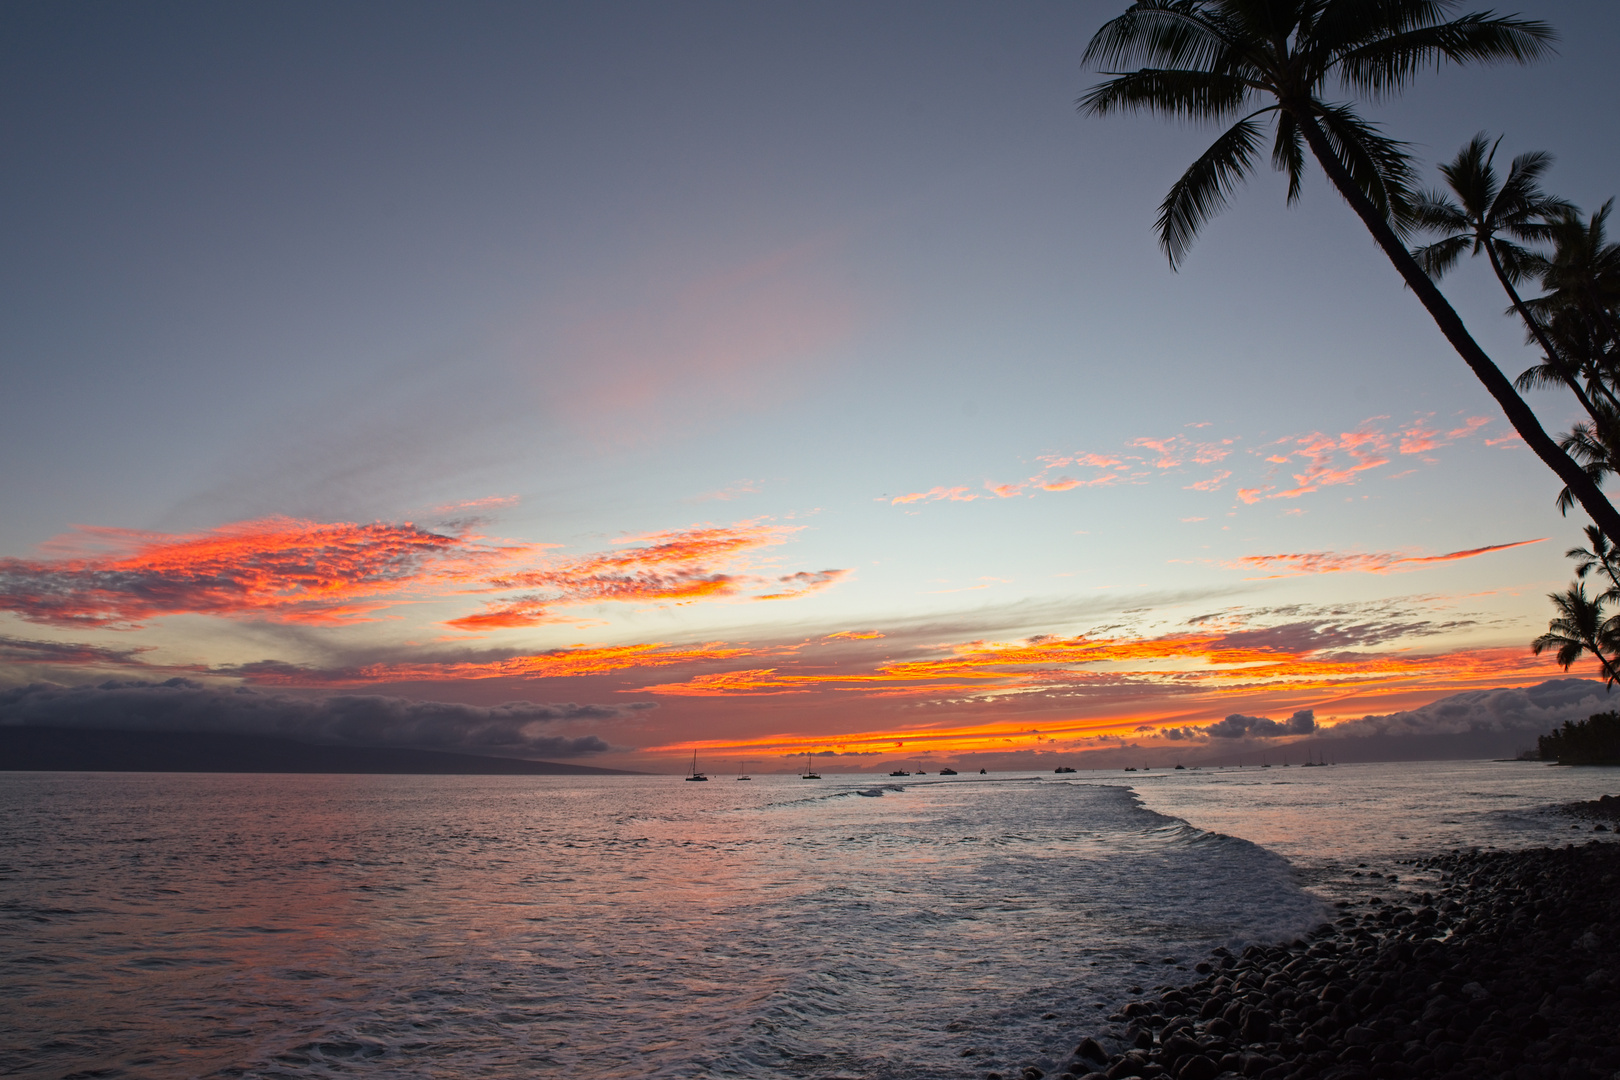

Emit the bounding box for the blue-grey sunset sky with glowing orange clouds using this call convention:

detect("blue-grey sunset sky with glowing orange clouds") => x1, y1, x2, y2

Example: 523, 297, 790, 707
0, 0, 1620, 771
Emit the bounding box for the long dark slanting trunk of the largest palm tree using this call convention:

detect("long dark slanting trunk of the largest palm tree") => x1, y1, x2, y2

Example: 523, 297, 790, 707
1283, 100, 1620, 542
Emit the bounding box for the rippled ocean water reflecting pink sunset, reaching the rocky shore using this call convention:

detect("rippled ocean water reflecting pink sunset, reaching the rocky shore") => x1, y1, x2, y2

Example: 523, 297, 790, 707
0, 763, 1620, 1078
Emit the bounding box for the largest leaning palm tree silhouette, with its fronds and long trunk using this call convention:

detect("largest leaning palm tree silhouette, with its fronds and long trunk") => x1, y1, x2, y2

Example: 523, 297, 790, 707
1081, 0, 1620, 542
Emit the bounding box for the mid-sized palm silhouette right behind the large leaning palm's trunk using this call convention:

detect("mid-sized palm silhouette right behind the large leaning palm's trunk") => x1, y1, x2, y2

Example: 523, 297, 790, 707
1413, 131, 1594, 419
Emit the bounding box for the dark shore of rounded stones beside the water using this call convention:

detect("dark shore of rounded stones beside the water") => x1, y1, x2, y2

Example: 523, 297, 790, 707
1017, 795, 1620, 1080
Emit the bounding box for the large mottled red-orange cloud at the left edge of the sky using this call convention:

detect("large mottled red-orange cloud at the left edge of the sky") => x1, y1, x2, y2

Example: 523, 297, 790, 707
0, 518, 518, 627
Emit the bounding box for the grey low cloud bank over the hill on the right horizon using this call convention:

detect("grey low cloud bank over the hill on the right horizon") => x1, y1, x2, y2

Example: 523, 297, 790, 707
1324, 678, 1620, 738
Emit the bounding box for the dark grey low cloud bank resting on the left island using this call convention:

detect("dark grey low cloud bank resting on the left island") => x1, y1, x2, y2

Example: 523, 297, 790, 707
0, 678, 656, 758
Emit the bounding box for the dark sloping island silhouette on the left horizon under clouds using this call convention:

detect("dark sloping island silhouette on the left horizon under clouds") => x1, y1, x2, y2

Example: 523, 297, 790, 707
0, 725, 643, 776
